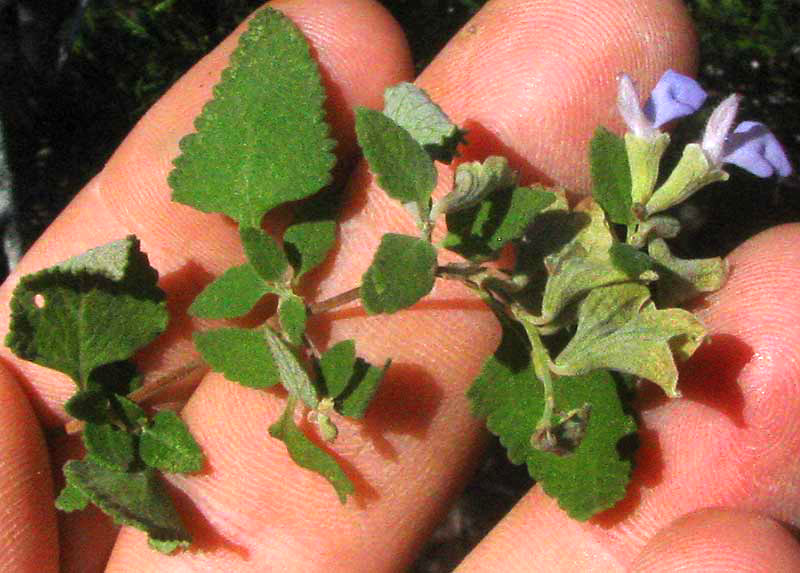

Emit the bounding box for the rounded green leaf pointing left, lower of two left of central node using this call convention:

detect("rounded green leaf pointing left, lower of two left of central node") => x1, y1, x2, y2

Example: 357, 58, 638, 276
194, 328, 280, 388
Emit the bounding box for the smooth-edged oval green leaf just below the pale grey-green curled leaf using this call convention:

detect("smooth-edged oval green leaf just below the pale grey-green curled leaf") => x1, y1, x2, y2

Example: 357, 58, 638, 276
356, 107, 437, 219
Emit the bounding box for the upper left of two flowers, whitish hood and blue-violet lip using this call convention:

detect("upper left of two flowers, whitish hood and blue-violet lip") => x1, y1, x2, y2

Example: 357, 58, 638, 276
617, 70, 707, 140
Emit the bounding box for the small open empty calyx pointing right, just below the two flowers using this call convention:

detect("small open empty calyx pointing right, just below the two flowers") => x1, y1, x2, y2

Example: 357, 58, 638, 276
647, 239, 728, 306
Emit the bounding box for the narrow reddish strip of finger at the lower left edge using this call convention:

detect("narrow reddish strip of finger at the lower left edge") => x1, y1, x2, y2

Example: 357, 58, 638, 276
0, 367, 58, 573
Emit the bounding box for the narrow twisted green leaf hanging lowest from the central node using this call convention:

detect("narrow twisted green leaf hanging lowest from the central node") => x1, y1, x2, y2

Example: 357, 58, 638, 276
269, 398, 355, 504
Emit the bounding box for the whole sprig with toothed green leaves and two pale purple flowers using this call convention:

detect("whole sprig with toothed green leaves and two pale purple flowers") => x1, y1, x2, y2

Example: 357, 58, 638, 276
6, 9, 791, 552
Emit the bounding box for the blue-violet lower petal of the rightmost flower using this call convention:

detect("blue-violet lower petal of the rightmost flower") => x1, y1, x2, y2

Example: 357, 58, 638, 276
722, 121, 792, 177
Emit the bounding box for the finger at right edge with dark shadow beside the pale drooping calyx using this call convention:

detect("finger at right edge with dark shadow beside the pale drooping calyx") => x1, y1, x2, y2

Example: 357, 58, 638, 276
464, 225, 800, 571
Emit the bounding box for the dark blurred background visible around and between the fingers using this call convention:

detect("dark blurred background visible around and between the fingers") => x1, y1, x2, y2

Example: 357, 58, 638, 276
0, 0, 800, 573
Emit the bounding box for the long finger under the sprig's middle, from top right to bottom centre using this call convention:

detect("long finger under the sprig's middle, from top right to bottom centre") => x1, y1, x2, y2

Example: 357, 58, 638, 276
104, 0, 691, 572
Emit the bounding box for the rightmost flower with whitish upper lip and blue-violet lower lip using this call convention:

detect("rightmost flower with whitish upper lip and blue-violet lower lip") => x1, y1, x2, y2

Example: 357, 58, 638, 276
700, 94, 792, 177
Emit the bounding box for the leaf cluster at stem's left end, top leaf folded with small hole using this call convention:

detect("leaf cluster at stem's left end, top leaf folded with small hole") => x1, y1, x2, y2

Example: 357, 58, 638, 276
6, 237, 203, 552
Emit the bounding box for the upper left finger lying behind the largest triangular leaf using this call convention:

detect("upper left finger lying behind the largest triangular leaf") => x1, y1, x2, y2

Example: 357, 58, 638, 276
0, 0, 412, 424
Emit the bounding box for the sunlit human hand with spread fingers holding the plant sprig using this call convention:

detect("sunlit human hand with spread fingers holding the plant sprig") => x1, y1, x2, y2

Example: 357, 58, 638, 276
0, 0, 800, 572
